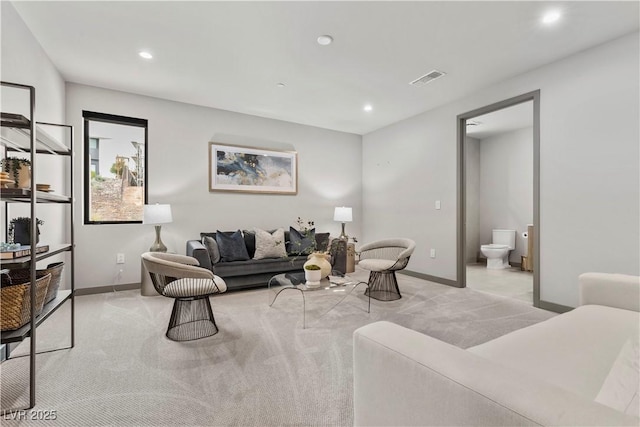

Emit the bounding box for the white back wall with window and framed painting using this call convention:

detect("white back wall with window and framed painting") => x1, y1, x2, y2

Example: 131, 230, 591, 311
67, 84, 362, 288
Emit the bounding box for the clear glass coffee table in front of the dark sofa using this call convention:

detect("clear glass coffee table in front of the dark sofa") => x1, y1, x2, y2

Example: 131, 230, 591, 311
268, 271, 371, 329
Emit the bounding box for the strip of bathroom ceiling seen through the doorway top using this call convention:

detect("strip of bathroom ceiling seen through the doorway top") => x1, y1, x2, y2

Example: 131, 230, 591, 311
467, 101, 533, 139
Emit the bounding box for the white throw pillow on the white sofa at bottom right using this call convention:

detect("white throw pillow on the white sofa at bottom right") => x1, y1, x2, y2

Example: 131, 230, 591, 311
595, 336, 640, 417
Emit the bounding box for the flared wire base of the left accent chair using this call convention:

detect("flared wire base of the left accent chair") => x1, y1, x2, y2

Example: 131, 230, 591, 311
167, 296, 218, 341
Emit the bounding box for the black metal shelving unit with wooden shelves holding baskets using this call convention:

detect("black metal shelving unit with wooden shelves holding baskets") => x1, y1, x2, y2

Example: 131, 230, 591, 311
0, 82, 75, 413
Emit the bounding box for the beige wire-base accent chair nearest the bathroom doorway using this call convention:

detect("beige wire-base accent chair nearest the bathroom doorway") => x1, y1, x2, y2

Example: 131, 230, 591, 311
358, 239, 416, 301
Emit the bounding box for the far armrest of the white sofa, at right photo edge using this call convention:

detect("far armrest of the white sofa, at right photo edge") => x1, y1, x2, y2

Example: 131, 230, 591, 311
578, 273, 640, 311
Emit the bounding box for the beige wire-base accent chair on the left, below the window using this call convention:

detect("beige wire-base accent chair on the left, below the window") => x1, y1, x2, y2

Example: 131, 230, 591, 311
142, 252, 227, 341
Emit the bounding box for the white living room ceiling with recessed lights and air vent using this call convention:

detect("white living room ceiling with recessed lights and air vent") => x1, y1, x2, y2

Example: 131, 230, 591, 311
11, 1, 640, 134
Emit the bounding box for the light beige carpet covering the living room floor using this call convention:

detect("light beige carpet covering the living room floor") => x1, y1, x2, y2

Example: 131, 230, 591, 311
0, 271, 553, 426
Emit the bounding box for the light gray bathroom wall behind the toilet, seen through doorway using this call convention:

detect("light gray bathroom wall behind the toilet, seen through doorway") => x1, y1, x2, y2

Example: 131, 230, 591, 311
478, 125, 533, 263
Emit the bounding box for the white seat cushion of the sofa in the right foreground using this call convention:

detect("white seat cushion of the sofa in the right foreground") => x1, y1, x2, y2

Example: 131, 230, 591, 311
468, 305, 640, 401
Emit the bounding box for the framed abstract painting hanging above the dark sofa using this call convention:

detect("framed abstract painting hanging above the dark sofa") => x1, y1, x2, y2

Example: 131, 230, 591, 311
209, 141, 298, 194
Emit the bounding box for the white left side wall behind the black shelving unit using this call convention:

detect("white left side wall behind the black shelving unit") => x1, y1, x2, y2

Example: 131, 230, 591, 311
0, 1, 70, 286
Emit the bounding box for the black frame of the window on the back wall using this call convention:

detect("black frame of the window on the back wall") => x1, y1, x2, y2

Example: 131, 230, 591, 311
82, 110, 149, 225
